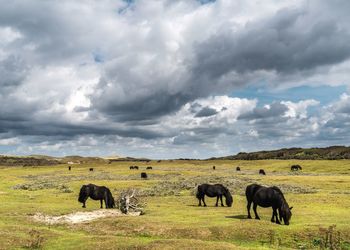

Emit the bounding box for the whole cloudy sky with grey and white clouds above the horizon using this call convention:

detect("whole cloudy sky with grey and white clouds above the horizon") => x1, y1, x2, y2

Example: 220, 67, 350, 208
0, 0, 350, 158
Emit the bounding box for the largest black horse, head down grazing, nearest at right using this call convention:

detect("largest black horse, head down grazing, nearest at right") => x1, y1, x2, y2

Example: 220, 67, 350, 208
245, 184, 293, 225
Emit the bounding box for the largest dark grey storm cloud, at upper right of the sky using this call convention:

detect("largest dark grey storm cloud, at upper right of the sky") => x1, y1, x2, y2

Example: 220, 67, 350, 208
193, 6, 350, 84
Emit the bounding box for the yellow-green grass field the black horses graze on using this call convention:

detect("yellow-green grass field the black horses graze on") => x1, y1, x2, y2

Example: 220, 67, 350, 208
0, 160, 350, 249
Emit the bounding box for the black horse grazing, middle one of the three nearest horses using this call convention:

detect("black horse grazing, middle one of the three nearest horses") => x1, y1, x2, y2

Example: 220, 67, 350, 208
196, 184, 233, 207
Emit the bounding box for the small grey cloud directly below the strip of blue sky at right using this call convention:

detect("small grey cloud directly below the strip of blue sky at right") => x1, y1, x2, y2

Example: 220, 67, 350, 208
238, 102, 288, 120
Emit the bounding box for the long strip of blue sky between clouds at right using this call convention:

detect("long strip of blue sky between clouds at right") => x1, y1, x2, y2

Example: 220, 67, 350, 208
230, 85, 347, 105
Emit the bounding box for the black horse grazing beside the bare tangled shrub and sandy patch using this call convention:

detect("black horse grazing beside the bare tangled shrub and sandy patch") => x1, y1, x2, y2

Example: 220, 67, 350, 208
78, 184, 115, 208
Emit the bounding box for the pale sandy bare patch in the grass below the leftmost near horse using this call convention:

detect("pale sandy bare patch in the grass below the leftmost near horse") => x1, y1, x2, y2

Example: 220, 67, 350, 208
33, 209, 141, 224
